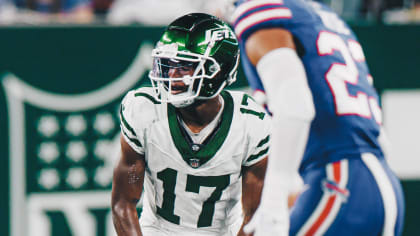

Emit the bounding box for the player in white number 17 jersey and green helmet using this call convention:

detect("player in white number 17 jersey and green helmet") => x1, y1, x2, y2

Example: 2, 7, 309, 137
112, 13, 271, 236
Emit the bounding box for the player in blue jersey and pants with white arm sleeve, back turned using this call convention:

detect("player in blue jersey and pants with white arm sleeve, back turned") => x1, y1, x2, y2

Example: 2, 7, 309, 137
220, 0, 404, 236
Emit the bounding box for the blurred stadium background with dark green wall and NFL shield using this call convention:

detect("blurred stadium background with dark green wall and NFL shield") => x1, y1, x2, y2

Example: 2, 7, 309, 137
0, 0, 420, 236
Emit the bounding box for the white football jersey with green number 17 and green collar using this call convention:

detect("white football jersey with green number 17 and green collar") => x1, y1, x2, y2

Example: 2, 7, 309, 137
120, 88, 271, 235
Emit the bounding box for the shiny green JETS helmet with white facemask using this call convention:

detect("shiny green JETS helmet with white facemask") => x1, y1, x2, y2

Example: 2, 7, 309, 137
149, 13, 239, 107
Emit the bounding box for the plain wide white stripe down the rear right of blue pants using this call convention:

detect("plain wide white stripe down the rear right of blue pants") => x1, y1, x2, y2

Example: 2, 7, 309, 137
362, 153, 398, 236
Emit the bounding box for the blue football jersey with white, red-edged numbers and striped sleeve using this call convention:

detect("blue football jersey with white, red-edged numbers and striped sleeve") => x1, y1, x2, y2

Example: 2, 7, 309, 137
232, 0, 383, 172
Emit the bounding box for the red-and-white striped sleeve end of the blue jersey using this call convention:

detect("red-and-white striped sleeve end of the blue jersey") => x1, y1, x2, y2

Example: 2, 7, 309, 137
230, 0, 293, 41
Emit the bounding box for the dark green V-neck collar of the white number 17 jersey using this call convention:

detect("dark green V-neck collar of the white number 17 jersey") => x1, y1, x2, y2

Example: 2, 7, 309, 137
168, 91, 233, 168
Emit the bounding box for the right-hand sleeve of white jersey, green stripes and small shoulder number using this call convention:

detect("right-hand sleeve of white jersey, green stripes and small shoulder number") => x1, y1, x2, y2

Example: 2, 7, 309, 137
242, 94, 271, 166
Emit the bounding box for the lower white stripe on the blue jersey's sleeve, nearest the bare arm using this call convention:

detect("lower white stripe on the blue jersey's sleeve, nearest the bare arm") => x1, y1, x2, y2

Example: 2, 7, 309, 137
235, 8, 292, 38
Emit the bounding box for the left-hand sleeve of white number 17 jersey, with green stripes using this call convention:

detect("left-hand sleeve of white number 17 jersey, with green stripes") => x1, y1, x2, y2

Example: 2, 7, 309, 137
120, 91, 144, 155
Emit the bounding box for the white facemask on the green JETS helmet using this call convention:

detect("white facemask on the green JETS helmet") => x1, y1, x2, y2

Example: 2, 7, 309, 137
149, 43, 220, 108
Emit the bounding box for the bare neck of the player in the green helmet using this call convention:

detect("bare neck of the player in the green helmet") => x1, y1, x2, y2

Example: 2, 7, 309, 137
178, 95, 222, 133
